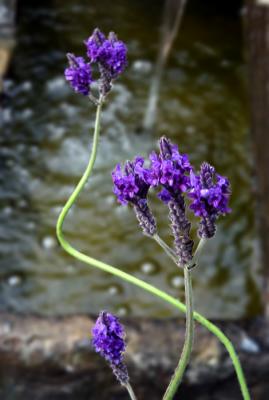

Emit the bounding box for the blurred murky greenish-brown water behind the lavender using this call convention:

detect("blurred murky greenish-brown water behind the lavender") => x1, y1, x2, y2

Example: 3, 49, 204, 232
0, 0, 260, 318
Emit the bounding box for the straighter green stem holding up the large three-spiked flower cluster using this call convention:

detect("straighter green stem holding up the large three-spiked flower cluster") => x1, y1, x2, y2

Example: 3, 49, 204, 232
163, 266, 194, 400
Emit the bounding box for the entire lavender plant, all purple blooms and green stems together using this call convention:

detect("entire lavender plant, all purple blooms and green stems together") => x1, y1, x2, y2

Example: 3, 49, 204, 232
56, 29, 250, 400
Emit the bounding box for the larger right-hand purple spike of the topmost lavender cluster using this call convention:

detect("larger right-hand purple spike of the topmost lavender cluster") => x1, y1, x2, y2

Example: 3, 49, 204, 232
85, 28, 127, 96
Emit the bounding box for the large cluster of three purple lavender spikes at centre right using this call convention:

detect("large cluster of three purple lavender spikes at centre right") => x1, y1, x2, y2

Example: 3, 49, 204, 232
112, 137, 231, 265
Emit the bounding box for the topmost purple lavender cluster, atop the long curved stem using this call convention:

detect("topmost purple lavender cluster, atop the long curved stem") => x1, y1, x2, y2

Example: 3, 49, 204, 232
65, 28, 127, 96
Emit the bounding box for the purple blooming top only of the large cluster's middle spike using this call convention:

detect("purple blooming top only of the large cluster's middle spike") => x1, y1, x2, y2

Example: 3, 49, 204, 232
149, 137, 192, 203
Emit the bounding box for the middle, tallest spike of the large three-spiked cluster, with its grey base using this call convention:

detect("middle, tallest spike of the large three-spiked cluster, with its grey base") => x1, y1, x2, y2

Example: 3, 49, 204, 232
149, 137, 194, 266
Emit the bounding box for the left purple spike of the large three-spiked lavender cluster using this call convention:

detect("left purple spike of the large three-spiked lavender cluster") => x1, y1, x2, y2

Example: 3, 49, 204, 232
112, 157, 157, 236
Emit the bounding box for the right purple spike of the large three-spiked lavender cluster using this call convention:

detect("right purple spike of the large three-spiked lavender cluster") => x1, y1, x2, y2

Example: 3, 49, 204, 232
189, 162, 231, 239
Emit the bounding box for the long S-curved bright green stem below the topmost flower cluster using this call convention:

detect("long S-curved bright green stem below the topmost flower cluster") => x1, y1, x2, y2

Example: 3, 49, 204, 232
56, 100, 250, 400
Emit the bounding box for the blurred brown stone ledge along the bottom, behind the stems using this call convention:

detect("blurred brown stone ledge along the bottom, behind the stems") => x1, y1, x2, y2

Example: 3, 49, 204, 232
0, 314, 269, 400
